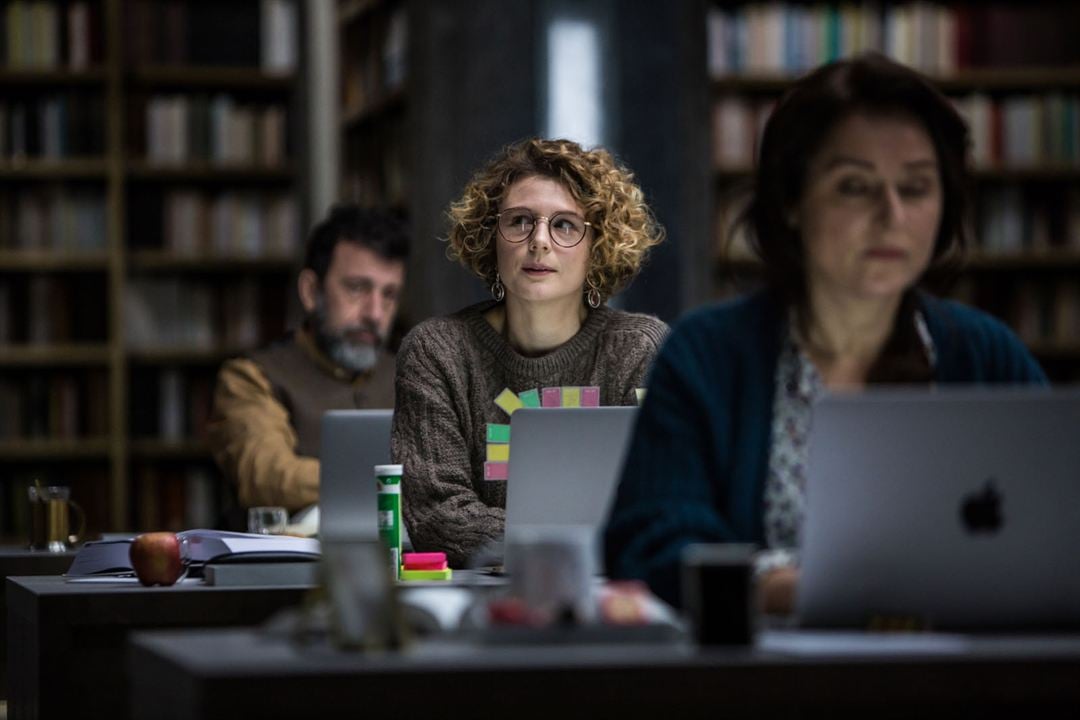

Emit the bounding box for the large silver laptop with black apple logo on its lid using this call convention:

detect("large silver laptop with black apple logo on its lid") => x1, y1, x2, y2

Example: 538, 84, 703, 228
796, 389, 1080, 629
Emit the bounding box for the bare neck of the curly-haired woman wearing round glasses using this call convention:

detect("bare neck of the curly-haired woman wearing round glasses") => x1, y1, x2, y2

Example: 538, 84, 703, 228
484, 296, 589, 357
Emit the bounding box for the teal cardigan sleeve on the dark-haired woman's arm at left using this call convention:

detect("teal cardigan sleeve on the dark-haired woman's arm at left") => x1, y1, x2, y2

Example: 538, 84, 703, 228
604, 321, 737, 606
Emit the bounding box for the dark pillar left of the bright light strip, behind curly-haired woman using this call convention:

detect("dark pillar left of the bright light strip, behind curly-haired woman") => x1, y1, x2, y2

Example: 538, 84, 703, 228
406, 0, 537, 321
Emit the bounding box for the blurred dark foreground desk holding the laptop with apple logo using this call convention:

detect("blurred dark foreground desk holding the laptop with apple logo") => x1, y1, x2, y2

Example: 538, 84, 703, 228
130, 629, 1080, 720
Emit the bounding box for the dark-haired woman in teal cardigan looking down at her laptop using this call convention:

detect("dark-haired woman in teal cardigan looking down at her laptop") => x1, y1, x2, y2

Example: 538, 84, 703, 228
605, 55, 1047, 612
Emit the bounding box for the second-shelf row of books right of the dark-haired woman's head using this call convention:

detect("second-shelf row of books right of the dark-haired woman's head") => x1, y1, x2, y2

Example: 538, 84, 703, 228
956, 93, 1080, 166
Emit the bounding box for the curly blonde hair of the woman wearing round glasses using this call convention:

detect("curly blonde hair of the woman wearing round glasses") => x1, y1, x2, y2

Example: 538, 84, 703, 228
446, 137, 664, 300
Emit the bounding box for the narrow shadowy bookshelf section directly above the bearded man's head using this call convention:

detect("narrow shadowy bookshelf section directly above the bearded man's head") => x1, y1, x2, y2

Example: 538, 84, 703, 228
338, 0, 408, 215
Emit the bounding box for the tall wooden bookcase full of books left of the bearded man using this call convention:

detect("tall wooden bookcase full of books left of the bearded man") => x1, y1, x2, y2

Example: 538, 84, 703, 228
0, 0, 306, 542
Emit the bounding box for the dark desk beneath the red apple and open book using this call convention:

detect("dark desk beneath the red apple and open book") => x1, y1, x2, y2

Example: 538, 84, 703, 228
6, 576, 310, 720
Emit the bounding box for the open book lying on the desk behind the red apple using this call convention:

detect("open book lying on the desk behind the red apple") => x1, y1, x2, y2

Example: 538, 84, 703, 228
66, 529, 321, 576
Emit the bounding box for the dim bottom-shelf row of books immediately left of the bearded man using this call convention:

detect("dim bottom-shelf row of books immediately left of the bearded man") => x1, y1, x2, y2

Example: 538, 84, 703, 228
132, 463, 222, 532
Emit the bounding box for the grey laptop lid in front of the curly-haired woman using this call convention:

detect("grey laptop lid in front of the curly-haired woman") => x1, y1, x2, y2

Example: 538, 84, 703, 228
503, 407, 637, 572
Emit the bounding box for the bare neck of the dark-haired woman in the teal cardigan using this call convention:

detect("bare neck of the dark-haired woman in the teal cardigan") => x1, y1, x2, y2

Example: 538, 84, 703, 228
799, 290, 901, 389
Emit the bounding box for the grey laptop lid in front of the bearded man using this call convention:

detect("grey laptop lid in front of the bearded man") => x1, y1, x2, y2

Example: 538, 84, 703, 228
319, 410, 393, 541
